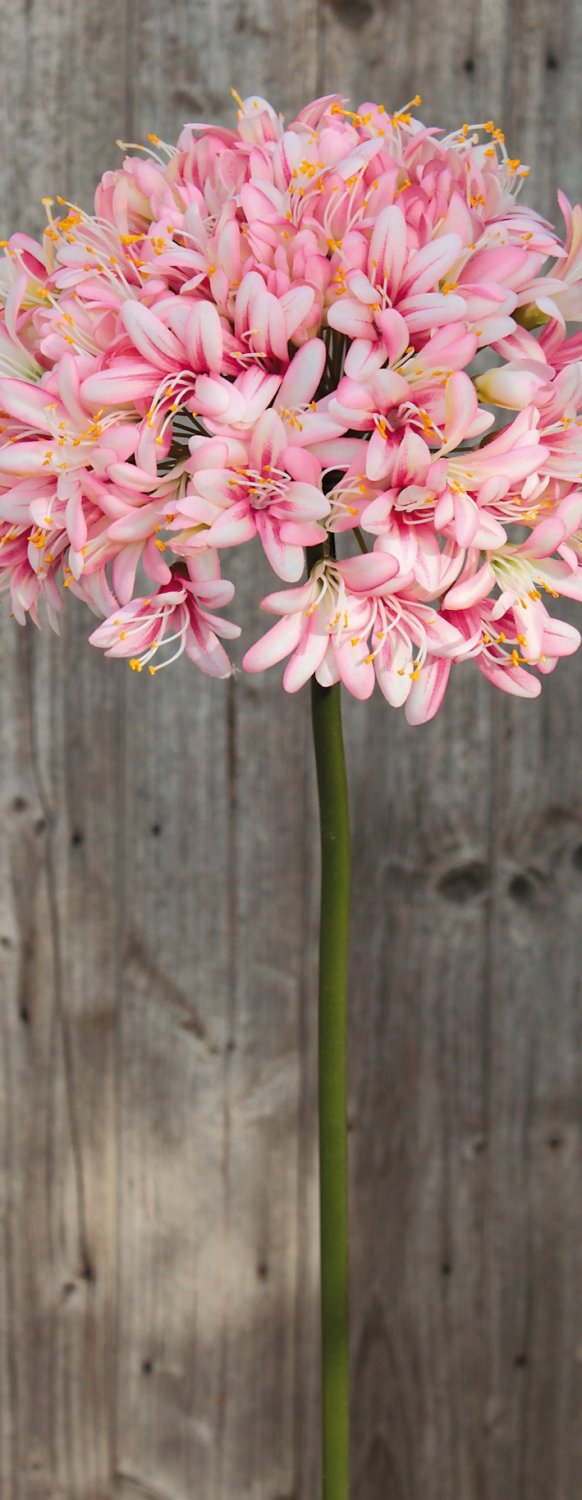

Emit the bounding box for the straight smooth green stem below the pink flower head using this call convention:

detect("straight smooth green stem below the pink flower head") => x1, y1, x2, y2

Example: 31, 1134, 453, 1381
312, 678, 350, 1500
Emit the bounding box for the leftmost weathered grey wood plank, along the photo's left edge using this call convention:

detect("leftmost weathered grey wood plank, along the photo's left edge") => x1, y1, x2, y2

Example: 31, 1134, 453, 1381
0, 5, 125, 1500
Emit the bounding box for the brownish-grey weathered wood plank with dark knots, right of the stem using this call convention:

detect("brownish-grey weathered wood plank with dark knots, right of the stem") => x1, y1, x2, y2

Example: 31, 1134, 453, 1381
323, 3, 582, 1500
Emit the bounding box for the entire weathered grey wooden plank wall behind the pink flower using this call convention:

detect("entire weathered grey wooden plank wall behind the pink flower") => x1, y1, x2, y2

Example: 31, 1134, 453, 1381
0, 0, 582, 1500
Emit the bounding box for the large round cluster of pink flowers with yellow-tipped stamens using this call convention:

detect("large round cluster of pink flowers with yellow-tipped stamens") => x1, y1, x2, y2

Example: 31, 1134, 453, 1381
0, 96, 582, 723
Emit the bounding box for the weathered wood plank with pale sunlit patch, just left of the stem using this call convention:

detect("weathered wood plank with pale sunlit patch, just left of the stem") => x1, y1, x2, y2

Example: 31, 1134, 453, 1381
110, 3, 315, 1500
